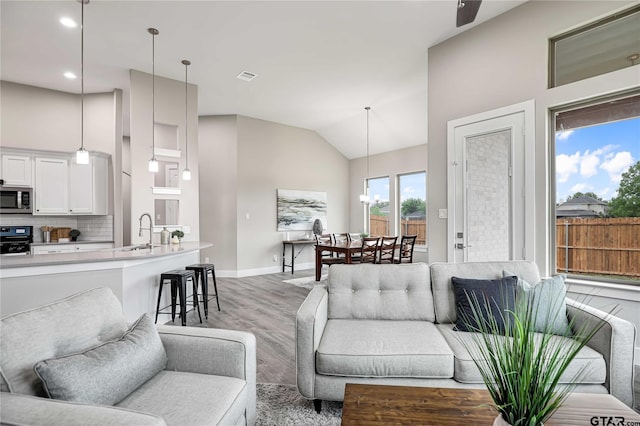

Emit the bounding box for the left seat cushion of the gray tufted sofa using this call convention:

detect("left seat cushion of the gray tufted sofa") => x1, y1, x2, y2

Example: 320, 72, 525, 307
316, 319, 453, 378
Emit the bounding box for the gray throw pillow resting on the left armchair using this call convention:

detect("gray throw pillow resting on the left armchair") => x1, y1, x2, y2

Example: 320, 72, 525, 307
34, 314, 167, 405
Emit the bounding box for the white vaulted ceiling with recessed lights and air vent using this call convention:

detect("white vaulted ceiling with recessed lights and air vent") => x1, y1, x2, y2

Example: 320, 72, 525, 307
0, 0, 525, 158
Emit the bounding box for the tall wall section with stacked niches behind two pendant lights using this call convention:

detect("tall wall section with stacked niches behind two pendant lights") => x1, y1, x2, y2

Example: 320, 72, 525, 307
129, 70, 200, 244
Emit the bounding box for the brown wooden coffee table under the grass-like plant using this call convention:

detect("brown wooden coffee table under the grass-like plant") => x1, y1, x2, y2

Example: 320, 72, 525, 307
342, 383, 640, 426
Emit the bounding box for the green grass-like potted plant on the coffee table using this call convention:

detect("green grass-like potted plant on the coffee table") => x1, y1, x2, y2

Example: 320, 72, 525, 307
458, 293, 612, 426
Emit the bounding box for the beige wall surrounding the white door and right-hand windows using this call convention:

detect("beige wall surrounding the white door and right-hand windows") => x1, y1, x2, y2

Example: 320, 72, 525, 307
427, 0, 640, 274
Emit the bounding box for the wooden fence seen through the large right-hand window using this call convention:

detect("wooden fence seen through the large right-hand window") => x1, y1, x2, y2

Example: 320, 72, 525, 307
556, 217, 640, 278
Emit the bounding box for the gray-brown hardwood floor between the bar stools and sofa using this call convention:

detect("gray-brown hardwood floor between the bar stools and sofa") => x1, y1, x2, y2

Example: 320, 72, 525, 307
167, 269, 314, 385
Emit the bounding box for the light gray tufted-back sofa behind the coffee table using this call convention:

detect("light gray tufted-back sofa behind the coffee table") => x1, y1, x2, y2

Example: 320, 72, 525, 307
296, 261, 636, 411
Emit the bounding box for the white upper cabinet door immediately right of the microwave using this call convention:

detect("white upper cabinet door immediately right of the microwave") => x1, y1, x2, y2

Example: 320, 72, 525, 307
33, 157, 69, 215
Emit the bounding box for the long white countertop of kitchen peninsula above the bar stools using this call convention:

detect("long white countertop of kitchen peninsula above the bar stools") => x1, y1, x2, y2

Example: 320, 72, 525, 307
0, 241, 213, 269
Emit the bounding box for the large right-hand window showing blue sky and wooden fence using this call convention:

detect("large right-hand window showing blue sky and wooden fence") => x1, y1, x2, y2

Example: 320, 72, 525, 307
552, 93, 640, 282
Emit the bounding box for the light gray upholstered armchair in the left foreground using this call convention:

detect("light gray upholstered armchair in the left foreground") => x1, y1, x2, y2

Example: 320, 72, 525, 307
0, 288, 256, 425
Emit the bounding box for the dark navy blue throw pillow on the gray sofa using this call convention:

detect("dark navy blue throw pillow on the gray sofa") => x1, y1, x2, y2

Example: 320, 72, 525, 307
451, 277, 518, 334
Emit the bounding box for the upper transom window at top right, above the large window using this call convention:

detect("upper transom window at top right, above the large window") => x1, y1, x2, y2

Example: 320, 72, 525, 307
549, 6, 640, 87
